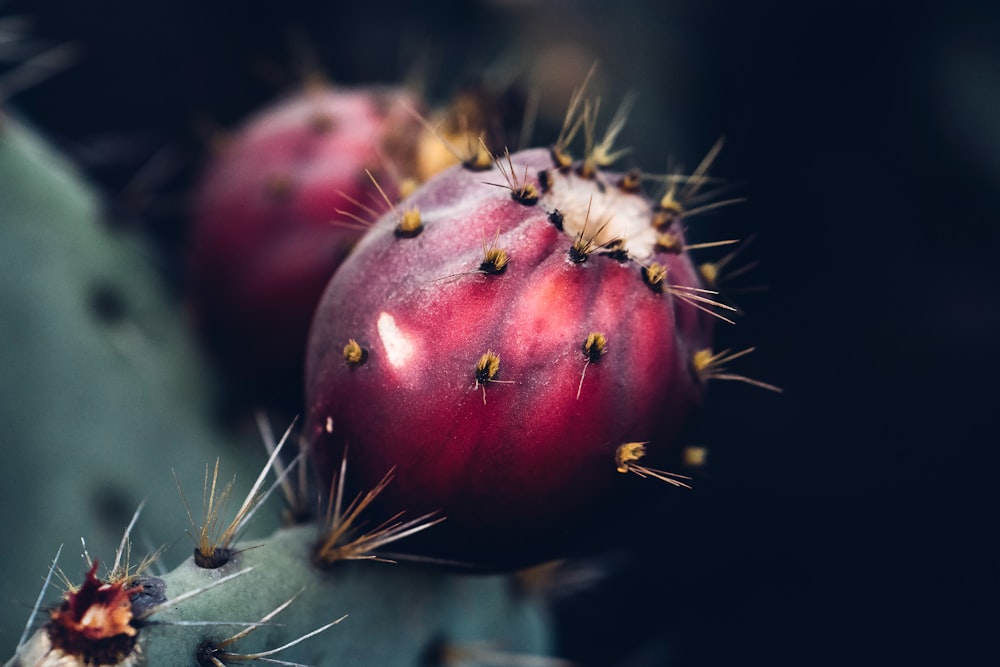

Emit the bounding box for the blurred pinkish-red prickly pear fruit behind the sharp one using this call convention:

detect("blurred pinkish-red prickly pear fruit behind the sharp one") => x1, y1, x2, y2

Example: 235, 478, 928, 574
189, 86, 419, 405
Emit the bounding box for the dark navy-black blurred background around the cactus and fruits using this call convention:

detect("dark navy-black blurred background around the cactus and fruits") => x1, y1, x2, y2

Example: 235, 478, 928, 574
0, 0, 1000, 666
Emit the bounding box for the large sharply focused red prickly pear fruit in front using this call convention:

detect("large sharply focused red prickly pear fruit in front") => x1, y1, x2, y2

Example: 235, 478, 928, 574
306, 150, 711, 569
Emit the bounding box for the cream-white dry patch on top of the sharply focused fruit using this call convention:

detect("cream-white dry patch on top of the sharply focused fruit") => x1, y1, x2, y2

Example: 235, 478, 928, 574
541, 170, 656, 260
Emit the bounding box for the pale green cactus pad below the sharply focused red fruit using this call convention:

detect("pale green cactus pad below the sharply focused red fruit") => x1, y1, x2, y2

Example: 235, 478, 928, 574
7, 526, 550, 667
